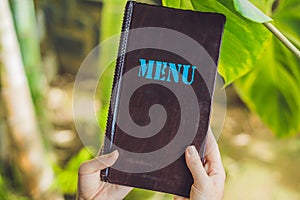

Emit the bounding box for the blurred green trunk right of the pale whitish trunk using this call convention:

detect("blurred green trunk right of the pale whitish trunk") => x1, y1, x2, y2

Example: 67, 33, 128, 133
9, 0, 53, 143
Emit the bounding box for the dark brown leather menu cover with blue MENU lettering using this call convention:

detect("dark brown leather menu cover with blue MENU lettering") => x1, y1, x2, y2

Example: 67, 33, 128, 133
101, 1, 225, 197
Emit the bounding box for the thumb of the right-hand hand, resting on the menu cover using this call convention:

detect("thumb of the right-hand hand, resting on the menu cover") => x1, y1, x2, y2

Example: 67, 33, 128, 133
185, 146, 208, 184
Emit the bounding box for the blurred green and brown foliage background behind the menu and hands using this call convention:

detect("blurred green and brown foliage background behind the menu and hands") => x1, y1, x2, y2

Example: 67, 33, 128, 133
0, 0, 300, 200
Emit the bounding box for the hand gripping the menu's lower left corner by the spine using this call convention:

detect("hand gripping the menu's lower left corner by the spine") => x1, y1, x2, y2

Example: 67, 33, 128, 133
77, 151, 132, 200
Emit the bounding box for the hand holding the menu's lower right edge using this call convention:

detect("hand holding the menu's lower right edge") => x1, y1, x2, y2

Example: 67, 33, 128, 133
174, 132, 226, 200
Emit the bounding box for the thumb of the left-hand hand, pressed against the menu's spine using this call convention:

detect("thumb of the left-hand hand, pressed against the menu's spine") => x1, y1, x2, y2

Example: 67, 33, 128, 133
78, 150, 119, 175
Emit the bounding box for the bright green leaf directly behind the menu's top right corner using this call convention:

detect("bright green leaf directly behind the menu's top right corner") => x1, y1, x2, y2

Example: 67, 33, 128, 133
163, 0, 271, 85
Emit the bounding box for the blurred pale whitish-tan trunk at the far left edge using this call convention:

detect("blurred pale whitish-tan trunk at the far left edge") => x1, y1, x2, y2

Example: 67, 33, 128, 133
0, 0, 53, 198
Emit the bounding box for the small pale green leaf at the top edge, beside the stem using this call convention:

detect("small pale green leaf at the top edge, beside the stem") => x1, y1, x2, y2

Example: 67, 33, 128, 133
233, 0, 272, 23
